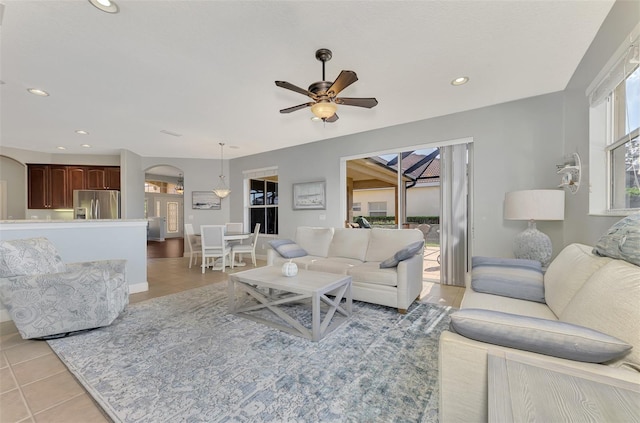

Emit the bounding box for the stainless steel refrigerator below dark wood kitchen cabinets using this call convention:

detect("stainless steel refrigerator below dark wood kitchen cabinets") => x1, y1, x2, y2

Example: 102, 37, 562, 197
73, 189, 120, 219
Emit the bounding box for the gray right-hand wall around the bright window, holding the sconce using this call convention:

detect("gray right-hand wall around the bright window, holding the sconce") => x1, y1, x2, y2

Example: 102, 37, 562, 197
563, 0, 640, 244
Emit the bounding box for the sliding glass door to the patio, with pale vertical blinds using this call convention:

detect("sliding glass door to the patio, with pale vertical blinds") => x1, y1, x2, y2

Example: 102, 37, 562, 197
341, 142, 471, 285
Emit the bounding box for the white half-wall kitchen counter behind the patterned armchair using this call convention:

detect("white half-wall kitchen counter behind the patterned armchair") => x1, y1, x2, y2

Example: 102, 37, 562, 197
0, 219, 149, 321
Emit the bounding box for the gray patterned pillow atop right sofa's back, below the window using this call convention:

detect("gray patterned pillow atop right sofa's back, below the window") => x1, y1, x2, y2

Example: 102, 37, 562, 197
593, 212, 640, 266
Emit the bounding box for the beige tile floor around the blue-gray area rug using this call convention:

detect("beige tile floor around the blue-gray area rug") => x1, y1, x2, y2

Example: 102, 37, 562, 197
0, 256, 464, 423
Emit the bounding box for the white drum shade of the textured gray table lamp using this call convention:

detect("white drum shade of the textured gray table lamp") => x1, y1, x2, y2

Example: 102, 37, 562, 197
504, 189, 564, 220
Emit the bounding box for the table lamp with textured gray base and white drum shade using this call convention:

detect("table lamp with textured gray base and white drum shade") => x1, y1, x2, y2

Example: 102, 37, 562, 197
504, 189, 564, 267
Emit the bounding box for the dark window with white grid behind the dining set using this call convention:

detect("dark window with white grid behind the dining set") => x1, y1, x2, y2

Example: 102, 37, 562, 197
249, 179, 278, 234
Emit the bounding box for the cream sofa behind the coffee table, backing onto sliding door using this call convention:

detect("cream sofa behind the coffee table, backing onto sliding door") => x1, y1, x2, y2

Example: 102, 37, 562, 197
267, 226, 424, 313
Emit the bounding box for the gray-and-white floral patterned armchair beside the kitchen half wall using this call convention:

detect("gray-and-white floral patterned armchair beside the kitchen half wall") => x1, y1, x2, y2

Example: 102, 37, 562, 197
0, 238, 129, 339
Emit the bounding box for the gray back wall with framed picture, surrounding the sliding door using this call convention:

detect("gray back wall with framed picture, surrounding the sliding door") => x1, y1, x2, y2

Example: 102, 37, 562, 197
230, 93, 563, 256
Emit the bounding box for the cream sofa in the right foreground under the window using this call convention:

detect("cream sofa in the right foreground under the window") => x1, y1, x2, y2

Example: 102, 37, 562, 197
439, 244, 640, 423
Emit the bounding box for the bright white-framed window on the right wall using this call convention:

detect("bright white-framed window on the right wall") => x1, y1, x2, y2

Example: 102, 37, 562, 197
587, 29, 640, 215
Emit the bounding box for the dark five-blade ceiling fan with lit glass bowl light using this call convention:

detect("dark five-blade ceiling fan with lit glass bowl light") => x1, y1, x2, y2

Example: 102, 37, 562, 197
276, 48, 378, 122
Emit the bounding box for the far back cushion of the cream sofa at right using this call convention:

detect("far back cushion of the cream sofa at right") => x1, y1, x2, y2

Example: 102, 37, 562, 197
544, 244, 611, 316
